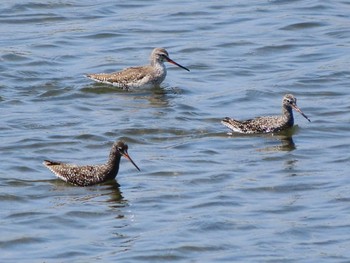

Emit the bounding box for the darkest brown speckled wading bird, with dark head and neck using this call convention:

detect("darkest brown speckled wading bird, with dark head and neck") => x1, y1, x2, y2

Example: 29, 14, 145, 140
43, 141, 140, 186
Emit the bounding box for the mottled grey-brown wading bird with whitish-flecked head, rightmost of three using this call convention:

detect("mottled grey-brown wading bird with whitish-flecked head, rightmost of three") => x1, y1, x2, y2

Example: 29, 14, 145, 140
221, 94, 310, 134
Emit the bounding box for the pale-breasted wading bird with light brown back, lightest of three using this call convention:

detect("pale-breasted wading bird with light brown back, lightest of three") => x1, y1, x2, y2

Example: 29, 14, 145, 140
86, 48, 190, 90
